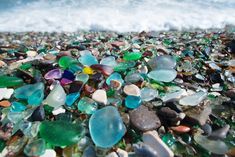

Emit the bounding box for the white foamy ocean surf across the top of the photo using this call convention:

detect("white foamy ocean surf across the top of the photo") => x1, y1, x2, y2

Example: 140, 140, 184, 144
0, 0, 235, 32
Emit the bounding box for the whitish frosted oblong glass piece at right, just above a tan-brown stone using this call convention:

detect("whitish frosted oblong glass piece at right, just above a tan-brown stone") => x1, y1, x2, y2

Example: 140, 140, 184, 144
179, 91, 207, 106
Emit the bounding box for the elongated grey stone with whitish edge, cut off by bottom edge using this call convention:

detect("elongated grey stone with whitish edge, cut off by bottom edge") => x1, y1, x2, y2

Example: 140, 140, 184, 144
142, 130, 174, 157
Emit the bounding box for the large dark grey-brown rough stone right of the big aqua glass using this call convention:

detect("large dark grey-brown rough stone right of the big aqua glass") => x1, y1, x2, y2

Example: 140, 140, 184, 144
129, 105, 161, 131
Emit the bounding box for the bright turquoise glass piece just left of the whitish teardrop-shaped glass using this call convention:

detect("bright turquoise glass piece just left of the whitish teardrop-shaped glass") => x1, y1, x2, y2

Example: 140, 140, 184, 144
28, 89, 44, 105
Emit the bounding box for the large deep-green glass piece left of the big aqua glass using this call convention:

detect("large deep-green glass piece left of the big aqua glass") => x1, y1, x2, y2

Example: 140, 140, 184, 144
39, 121, 85, 146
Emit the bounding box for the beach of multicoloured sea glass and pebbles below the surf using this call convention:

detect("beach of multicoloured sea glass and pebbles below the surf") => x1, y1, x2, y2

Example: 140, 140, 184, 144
0, 27, 235, 157
